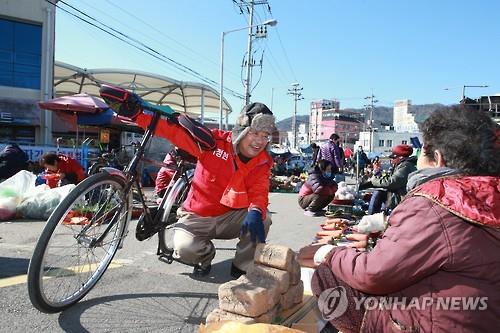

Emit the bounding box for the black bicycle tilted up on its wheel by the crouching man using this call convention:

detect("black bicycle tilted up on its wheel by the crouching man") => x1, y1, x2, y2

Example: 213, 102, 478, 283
28, 87, 194, 313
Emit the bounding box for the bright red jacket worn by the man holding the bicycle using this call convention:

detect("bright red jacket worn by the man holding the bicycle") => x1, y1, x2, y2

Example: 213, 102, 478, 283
137, 114, 272, 218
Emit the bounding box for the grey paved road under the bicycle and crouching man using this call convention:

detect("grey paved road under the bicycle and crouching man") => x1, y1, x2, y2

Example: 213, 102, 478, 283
0, 193, 322, 332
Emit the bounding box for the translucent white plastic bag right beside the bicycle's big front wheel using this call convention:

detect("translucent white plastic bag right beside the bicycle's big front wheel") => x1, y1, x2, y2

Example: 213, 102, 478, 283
17, 184, 76, 220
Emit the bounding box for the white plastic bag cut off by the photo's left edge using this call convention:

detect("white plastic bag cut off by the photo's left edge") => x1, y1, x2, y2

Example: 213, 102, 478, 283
0, 170, 36, 221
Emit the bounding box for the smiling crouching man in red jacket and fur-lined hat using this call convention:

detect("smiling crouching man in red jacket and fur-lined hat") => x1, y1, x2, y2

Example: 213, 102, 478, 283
133, 103, 276, 277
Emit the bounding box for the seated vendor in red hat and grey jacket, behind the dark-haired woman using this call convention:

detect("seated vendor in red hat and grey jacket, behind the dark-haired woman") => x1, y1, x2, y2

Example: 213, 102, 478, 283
359, 145, 417, 215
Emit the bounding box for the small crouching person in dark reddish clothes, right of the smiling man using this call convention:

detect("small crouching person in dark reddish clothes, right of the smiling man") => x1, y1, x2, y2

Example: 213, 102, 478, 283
299, 160, 337, 216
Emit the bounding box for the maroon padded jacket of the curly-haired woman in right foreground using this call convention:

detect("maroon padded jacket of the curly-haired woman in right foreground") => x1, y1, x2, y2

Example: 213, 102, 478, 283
329, 177, 500, 332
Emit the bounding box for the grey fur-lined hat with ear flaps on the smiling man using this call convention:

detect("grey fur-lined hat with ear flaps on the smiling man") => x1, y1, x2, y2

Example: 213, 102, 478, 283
232, 102, 276, 146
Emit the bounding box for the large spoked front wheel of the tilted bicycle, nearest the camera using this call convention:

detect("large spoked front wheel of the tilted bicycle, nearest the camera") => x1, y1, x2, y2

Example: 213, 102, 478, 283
28, 172, 132, 313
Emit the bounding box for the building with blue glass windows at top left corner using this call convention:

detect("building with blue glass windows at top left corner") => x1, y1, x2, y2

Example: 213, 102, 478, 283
0, 0, 55, 144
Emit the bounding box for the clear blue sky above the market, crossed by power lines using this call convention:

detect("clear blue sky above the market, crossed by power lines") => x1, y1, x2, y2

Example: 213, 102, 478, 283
56, 0, 500, 121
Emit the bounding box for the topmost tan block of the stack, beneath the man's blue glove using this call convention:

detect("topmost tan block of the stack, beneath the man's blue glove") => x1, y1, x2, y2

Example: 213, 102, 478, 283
254, 244, 295, 272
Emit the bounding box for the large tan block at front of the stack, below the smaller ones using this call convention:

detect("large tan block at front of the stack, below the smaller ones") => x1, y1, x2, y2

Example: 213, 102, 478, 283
219, 275, 280, 317
